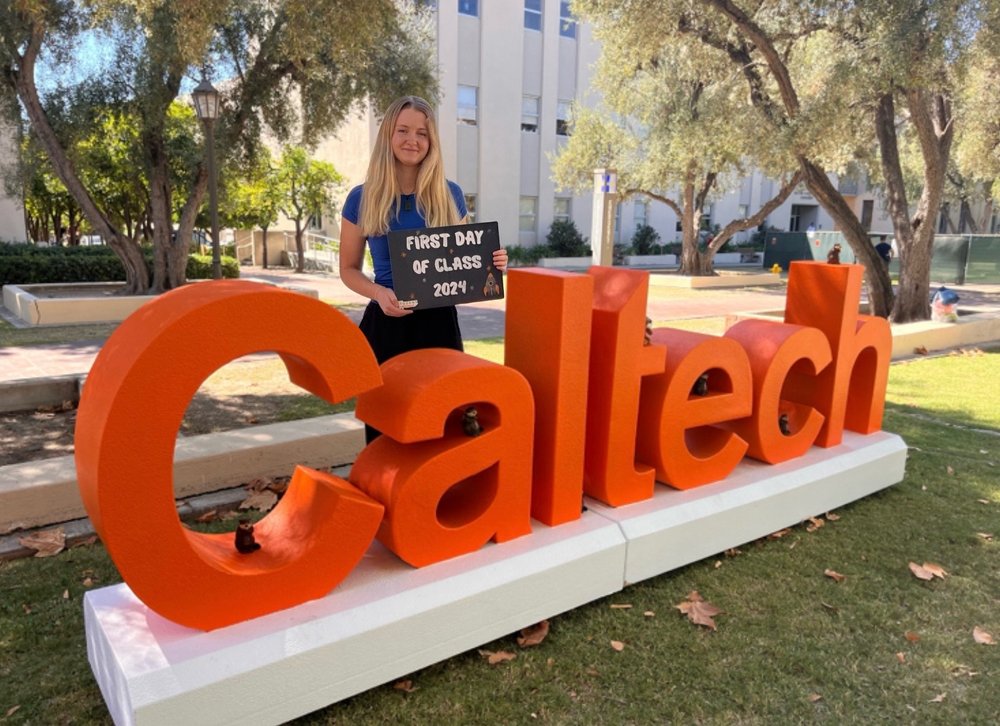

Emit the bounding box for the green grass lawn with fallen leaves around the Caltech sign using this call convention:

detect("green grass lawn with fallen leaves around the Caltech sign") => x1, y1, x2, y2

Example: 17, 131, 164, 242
0, 350, 1000, 724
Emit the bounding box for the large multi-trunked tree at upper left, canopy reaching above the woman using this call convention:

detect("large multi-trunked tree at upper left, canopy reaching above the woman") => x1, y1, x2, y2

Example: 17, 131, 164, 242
0, 0, 436, 293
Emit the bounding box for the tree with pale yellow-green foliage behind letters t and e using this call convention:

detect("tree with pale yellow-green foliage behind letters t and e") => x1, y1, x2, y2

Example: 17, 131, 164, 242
553, 1, 802, 275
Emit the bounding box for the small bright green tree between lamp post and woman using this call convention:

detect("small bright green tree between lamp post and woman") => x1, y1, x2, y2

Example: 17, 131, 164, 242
276, 146, 344, 272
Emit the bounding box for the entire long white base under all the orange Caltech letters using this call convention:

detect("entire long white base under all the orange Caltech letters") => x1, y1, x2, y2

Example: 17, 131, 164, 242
84, 433, 906, 724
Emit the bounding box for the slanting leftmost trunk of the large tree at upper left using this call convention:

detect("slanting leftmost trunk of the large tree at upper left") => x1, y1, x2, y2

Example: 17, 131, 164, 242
8, 24, 149, 295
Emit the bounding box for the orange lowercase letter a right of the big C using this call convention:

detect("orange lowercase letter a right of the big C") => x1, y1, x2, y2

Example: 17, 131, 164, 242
350, 348, 535, 567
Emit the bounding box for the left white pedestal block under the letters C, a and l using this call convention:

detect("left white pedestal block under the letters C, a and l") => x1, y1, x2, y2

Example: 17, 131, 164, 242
84, 513, 625, 726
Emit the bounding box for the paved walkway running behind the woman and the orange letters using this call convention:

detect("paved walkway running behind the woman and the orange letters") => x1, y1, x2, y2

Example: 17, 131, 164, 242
0, 268, 1000, 390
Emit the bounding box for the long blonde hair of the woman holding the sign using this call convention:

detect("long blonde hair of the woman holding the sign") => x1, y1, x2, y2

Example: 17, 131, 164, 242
358, 96, 462, 237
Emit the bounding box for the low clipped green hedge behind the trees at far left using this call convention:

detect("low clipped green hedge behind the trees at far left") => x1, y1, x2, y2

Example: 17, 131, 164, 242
0, 244, 240, 285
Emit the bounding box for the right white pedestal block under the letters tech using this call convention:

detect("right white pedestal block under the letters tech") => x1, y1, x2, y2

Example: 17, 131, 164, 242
587, 431, 906, 584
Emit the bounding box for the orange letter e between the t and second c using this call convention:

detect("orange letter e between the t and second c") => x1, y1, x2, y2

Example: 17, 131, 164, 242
637, 328, 752, 489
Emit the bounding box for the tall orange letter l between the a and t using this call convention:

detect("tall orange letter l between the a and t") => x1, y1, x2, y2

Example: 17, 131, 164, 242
504, 269, 594, 527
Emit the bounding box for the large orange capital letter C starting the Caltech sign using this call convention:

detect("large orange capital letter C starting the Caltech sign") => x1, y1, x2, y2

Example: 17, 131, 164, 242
76, 280, 382, 630
